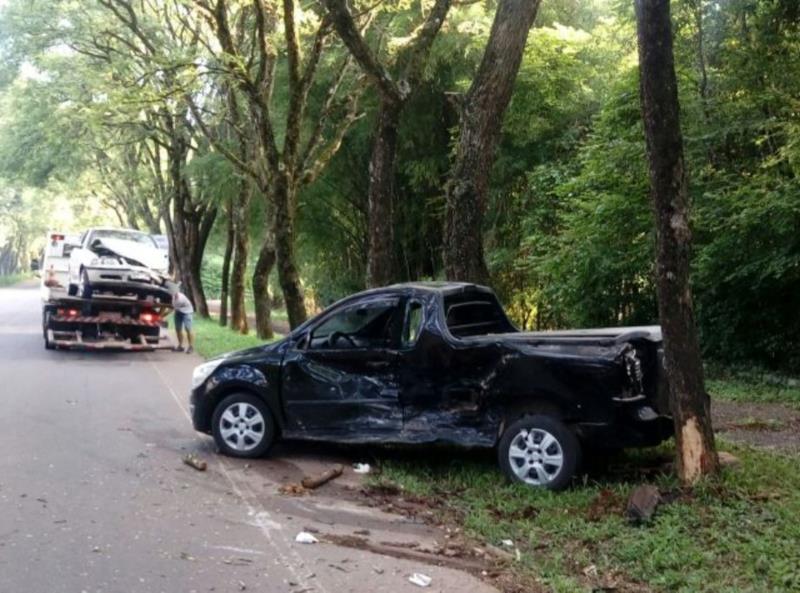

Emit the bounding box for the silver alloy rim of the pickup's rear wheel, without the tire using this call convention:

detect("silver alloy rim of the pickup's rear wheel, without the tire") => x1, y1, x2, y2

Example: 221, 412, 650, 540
508, 428, 564, 486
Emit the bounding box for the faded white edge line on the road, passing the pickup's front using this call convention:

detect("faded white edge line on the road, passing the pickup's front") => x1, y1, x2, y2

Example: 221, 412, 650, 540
147, 355, 328, 593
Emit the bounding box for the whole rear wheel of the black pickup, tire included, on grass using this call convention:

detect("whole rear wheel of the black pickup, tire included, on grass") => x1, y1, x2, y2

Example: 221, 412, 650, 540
497, 415, 581, 490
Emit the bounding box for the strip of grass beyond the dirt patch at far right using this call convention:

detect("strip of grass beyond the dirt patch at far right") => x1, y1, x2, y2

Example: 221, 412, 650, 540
706, 369, 800, 407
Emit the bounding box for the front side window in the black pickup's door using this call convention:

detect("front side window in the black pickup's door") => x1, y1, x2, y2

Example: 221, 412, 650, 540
309, 300, 398, 350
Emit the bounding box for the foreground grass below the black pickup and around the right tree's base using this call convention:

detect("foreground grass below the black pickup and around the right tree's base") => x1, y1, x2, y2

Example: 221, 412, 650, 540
373, 446, 800, 593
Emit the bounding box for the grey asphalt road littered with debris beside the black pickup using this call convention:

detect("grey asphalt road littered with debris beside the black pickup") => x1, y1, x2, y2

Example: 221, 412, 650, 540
0, 286, 492, 593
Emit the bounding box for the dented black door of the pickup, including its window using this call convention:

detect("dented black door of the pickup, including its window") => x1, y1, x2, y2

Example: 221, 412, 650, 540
282, 297, 402, 434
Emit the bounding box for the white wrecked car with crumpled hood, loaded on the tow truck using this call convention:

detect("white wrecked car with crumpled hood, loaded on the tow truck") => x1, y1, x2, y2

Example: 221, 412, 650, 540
68, 228, 170, 302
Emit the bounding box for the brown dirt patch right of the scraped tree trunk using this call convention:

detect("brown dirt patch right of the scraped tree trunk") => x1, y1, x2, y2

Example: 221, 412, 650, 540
711, 400, 800, 453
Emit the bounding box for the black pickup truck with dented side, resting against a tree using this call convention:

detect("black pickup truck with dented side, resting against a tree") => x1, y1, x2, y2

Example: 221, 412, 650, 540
191, 282, 672, 489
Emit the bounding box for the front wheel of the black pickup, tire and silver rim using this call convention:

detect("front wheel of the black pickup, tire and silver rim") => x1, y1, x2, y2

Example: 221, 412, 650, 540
211, 393, 275, 457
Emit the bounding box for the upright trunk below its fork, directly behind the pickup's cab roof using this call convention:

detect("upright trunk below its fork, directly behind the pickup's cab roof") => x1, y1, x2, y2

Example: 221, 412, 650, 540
367, 97, 402, 287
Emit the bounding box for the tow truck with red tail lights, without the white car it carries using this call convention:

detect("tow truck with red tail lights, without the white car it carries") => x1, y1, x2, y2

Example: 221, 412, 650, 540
39, 231, 172, 350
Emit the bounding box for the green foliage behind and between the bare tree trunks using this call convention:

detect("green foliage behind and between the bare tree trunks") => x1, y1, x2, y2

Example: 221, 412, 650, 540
0, 0, 800, 371
